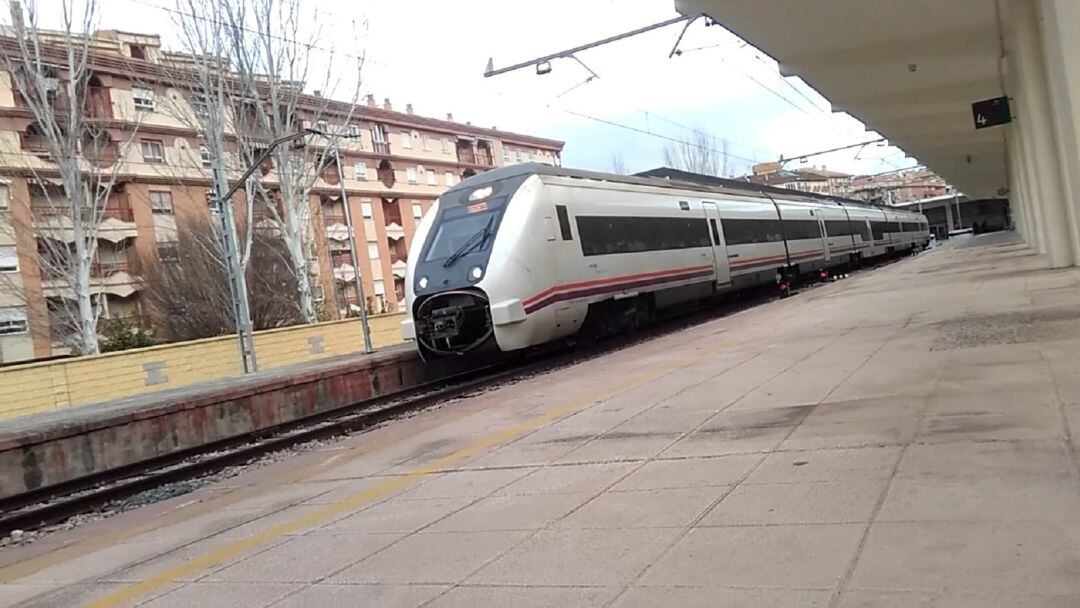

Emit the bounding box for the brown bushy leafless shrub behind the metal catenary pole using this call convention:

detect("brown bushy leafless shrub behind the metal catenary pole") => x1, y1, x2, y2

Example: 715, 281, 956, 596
143, 213, 302, 340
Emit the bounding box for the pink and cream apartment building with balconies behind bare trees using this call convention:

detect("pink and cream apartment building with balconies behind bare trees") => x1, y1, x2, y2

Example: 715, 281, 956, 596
0, 31, 563, 363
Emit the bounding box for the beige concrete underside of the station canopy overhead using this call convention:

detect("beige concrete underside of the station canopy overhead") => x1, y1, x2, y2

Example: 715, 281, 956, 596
675, 0, 1008, 198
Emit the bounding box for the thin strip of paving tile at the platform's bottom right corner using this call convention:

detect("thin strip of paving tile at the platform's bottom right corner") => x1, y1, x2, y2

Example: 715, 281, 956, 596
838, 590, 1080, 608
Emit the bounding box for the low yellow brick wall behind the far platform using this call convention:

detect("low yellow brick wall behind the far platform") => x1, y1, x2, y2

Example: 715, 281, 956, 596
0, 314, 402, 420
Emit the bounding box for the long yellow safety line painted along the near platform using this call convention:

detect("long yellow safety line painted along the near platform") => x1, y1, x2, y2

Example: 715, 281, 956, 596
86, 348, 723, 608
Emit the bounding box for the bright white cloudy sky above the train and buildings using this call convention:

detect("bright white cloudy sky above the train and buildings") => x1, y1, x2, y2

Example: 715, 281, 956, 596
24, 0, 915, 174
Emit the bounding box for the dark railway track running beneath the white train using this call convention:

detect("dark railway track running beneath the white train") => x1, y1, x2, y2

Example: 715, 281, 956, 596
0, 259, 894, 536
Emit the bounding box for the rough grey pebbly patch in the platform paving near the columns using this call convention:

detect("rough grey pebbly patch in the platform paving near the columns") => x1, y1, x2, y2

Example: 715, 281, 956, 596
930, 307, 1080, 351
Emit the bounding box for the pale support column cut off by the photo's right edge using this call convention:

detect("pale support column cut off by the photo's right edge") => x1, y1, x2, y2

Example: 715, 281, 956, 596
1039, 0, 1080, 265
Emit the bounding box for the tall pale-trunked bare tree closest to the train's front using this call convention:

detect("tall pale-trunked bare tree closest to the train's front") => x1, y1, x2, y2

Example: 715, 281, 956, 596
218, 0, 360, 323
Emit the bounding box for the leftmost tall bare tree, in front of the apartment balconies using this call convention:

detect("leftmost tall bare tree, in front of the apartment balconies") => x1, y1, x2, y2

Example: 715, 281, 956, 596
0, 0, 137, 354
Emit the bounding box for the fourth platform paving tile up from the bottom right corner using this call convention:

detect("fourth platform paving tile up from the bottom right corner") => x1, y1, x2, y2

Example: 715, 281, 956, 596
896, 441, 1072, 477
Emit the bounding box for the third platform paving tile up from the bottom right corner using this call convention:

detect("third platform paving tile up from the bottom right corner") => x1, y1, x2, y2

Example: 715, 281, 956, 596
877, 475, 1080, 522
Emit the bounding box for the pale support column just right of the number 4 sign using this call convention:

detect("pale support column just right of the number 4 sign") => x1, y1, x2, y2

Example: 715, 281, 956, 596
1010, 0, 1074, 268
